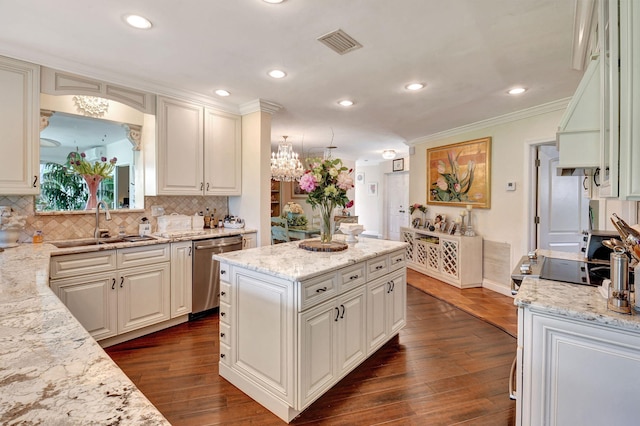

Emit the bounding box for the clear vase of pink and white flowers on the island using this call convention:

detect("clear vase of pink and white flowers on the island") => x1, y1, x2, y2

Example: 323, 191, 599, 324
300, 158, 353, 244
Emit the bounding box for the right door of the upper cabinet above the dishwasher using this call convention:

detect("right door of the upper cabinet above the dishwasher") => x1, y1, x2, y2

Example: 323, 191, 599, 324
204, 108, 242, 195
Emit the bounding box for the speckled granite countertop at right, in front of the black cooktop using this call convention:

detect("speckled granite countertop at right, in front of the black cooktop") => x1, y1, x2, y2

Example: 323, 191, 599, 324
514, 277, 640, 332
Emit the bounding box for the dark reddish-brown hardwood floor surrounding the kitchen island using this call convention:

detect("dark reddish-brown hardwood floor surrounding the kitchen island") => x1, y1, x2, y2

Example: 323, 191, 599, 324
106, 273, 516, 426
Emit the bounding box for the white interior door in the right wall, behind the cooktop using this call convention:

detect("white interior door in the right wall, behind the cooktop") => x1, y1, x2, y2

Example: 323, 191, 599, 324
538, 145, 589, 253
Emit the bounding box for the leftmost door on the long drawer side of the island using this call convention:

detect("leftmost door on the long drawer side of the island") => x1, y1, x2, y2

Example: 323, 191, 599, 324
299, 300, 340, 407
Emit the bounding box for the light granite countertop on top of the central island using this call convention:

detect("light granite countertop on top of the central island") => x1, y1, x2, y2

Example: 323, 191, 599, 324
213, 238, 408, 281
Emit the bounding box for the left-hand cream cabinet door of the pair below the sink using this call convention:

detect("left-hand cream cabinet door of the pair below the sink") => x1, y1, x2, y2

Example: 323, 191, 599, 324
51, 272, 118, 340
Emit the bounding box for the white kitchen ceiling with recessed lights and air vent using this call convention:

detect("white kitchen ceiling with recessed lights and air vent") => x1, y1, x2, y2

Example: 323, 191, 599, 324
0, 0, 582, 161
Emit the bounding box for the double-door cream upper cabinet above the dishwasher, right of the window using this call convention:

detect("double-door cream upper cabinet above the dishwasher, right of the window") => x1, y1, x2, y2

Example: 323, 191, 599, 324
156, 96, 242, 195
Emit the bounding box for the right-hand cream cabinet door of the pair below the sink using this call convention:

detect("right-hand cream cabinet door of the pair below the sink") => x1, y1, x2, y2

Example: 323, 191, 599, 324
116, 262, 171, 333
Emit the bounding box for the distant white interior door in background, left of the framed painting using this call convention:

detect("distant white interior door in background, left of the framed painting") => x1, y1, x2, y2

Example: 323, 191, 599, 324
385, 172, 409, 241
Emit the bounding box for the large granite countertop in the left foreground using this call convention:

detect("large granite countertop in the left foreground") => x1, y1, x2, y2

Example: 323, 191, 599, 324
0, 244, 169, 426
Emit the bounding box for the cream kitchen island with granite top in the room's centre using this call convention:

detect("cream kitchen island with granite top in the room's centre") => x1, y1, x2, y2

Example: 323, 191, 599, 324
214, 238, 406, 422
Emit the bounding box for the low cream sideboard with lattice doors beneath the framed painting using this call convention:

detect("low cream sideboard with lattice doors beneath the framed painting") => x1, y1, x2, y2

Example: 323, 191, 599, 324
400, 228, 482, 288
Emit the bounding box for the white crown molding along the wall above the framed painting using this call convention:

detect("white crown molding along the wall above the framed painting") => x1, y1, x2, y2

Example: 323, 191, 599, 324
405, 98, 571, 146
